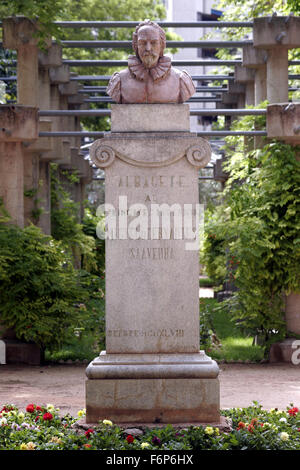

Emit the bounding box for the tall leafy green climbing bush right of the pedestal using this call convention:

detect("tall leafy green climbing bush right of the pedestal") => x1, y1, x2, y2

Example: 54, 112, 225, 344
202, 106, 300, 344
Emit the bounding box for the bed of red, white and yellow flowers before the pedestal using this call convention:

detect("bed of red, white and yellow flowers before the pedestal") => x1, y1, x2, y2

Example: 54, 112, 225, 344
0, 402, 300, 451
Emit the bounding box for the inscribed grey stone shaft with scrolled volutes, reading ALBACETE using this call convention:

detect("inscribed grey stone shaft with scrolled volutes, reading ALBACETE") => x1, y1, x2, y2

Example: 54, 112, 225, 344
91, 133, 210, 353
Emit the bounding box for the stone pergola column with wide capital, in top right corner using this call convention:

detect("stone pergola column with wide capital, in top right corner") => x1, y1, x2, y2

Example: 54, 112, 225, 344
253, 16, 300, 103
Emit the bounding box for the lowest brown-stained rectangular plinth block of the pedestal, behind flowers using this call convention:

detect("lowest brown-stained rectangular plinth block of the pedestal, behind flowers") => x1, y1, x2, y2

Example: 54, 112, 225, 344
86, 379, 220, 423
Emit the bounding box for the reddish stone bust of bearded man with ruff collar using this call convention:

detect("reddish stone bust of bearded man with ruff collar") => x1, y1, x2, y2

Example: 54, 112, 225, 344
107, 20, 196, 104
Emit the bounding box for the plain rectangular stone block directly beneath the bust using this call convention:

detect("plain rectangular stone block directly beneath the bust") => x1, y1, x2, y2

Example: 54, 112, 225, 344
111, 104, 190, 132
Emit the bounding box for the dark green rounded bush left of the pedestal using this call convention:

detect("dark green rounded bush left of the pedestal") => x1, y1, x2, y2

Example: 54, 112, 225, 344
0, 224, 85, 348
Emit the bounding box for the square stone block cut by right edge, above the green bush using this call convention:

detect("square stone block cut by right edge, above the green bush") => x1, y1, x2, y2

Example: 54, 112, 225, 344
267, 103, 300, 144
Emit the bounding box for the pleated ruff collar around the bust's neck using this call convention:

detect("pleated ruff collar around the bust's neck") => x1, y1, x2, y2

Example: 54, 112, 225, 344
128, 55, 171, 81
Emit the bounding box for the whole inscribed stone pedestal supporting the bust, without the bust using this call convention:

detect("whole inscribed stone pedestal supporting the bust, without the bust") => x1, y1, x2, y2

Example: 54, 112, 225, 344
86, 104, 220, 423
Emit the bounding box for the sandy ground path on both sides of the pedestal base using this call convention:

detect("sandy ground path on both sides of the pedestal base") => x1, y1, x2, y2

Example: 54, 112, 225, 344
0, 364, 300, 415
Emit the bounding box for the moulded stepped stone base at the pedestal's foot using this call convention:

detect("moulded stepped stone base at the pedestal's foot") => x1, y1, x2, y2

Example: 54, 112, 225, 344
86, 351, 220, 424
